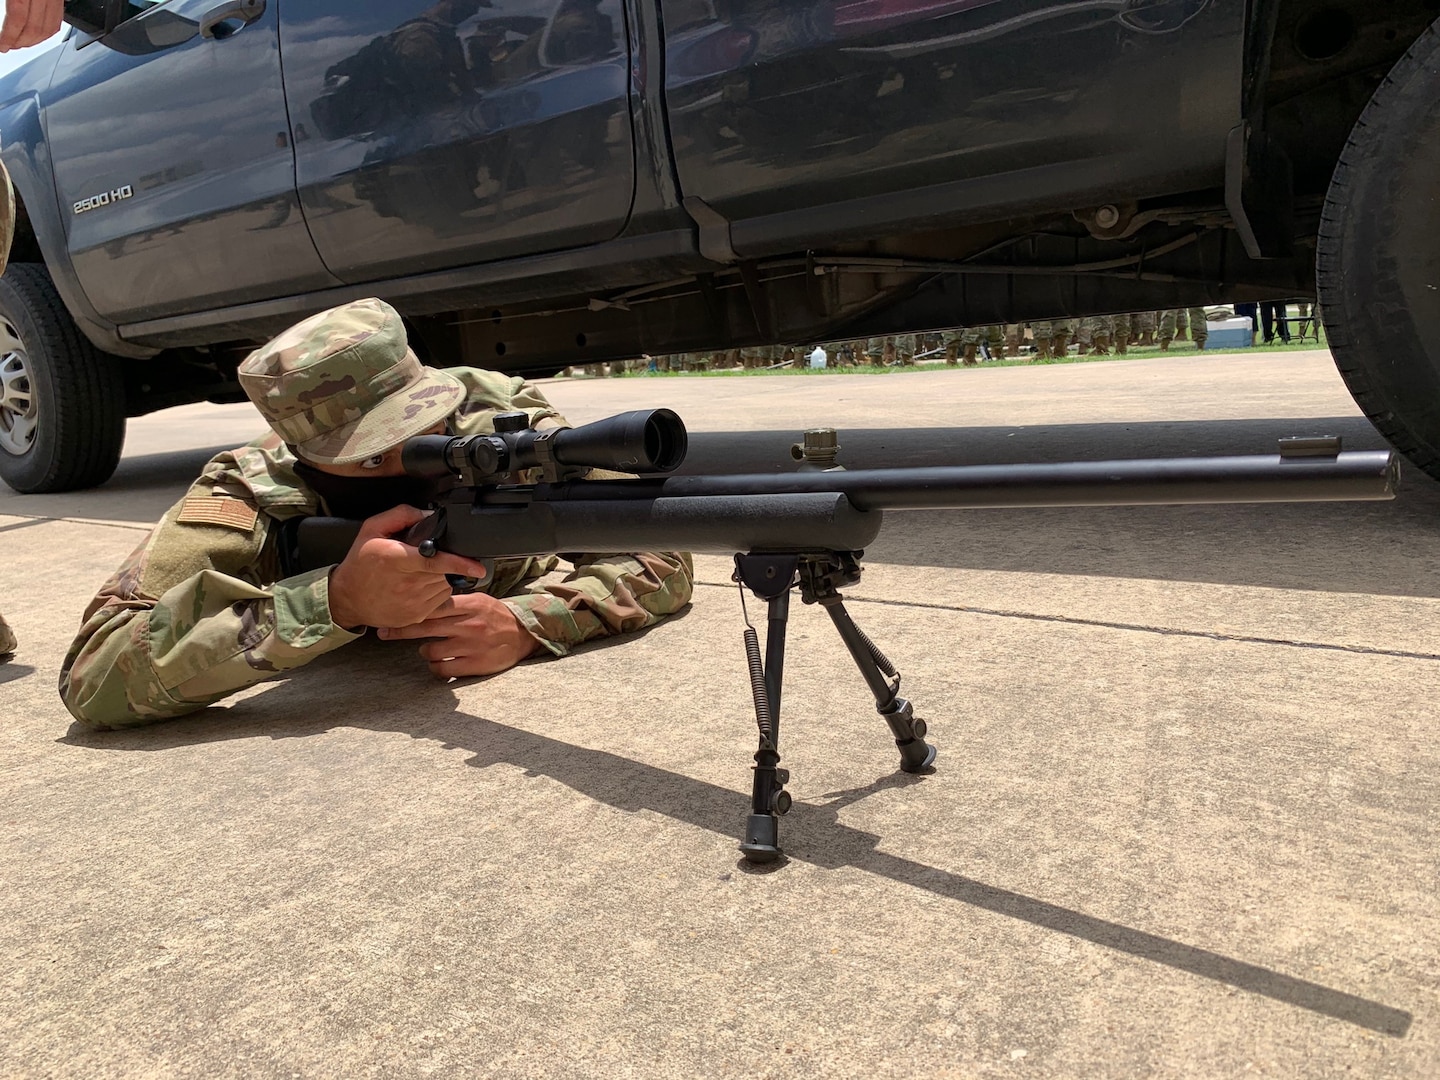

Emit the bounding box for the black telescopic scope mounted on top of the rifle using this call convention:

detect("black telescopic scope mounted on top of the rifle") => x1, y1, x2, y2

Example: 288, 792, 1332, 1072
400, 409, 688, 484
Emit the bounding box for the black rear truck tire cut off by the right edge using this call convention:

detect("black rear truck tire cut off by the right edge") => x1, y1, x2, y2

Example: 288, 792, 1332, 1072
1316, 23, 1440, 478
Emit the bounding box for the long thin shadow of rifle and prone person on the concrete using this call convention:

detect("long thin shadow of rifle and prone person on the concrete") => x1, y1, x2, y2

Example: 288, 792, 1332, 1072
59, 642, 1413, 1035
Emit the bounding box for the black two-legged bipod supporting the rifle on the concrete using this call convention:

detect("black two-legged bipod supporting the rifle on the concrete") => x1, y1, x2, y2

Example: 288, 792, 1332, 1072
733, 552, 935, 863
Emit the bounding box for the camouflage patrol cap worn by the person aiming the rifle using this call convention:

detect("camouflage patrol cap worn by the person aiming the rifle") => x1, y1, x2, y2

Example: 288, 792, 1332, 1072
239, 298, 465, 465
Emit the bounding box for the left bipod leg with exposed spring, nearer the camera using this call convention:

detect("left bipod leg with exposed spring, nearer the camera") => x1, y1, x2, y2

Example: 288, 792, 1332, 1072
734, 554, 799, 863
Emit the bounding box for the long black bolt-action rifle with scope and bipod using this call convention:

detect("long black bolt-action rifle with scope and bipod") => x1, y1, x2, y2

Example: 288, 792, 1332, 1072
284, 409, 1400, 861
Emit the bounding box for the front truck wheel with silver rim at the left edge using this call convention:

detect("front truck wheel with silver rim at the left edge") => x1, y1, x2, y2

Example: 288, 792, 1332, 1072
0, 262, 125, 494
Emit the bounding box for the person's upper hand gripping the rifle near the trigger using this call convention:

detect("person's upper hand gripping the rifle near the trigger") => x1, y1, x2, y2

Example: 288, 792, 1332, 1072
330, 505, 485, 629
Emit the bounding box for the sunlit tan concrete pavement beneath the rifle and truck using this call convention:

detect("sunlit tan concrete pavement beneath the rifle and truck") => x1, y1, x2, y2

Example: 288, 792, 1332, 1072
0, 353, 1440, 1077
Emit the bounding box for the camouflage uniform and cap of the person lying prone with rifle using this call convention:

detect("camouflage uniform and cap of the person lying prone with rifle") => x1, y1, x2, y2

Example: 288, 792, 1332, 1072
60, 300, 693, 727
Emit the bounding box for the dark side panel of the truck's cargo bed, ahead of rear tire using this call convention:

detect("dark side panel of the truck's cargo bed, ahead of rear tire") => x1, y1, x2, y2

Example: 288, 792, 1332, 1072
660, 0, 1246, 247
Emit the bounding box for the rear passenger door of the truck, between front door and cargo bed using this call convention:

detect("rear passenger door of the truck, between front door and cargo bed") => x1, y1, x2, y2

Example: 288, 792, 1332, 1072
281, 0, 635, 282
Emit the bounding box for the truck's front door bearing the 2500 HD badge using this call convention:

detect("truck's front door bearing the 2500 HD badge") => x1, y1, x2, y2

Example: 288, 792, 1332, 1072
43, 0, 337, 323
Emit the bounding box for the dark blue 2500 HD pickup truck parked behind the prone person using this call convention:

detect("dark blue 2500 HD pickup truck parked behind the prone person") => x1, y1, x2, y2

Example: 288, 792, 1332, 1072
0, 0, 1440, 491
